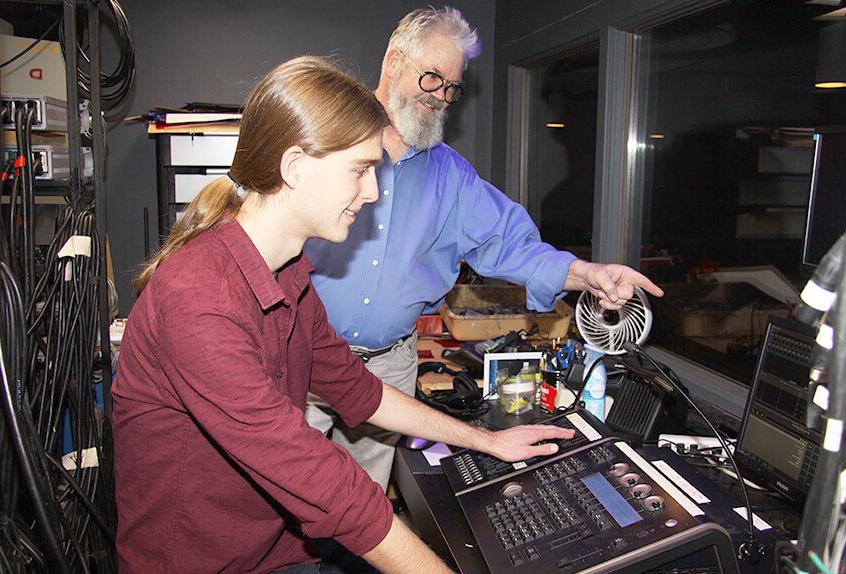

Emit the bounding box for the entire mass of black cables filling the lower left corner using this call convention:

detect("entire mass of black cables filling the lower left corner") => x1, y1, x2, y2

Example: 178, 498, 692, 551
0, 208, 115, 572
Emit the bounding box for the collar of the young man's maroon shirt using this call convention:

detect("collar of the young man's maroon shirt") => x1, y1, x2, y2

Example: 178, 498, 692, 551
218, 217, 313, 310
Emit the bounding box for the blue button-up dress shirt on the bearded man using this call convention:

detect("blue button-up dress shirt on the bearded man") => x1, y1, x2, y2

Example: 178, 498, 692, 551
304, 143, 575, 349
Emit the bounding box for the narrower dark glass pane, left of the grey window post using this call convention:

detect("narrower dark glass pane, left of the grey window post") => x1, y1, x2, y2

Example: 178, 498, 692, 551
528, 45, 599, 259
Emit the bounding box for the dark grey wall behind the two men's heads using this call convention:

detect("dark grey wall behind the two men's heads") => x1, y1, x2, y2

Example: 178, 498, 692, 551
103, 0, 495, 316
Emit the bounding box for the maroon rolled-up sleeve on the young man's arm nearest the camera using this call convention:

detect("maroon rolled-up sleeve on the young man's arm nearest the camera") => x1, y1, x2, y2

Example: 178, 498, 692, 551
160, 298, 391, 554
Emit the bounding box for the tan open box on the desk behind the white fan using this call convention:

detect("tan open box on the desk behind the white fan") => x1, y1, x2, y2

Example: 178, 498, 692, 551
438, 285, 573, 341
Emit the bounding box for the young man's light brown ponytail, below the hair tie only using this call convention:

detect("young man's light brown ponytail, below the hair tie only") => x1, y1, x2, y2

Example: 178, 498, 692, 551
132, 176, 243, 295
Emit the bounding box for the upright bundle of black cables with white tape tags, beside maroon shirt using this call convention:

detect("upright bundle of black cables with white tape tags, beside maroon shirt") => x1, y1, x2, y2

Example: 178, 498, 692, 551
27, 209, 114, 572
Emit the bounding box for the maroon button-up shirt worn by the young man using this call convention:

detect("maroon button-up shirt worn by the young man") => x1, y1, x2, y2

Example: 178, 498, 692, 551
112, 220, 391, 573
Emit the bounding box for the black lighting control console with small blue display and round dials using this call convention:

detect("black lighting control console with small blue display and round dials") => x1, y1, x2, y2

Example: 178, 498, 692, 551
442, 437, 737, 574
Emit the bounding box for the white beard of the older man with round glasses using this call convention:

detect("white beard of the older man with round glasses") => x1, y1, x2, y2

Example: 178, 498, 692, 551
388, 77, 446, 149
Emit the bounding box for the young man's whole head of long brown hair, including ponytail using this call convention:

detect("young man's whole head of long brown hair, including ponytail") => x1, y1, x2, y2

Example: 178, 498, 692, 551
132, 56, 389, 294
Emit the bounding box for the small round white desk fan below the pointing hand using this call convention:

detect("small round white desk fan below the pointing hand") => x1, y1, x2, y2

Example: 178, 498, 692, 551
576, 287, 652, 355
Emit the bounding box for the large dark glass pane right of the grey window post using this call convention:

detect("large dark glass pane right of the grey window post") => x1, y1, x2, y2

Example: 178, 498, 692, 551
639, 0, 846, 384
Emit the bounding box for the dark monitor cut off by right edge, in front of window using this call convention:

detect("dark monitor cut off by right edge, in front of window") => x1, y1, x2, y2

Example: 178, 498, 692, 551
802, 126, 846, 265
